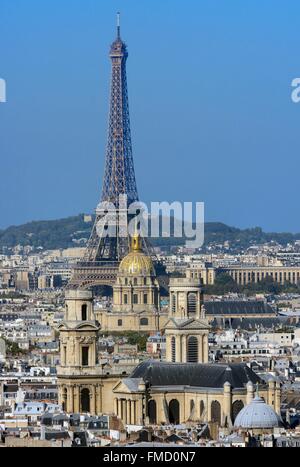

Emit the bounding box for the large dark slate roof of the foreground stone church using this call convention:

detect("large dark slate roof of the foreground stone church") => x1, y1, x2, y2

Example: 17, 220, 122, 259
131, 360, 265, 389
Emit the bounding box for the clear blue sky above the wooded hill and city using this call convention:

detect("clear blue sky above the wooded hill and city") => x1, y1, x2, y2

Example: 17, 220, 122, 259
0, 0, 300, 232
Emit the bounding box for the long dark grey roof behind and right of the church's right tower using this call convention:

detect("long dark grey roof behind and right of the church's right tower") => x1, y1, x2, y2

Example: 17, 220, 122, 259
205, 300, 276, 316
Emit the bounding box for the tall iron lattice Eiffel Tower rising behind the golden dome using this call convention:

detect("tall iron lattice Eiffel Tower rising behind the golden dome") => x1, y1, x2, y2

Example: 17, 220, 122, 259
67, 13, 148, 288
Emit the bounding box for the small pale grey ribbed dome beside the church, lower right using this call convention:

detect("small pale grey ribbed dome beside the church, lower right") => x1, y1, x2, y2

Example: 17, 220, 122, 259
234, 395, 282, 429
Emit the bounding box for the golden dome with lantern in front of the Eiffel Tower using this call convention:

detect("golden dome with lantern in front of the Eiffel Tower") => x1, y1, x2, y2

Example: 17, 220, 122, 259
119, 234, 154, 276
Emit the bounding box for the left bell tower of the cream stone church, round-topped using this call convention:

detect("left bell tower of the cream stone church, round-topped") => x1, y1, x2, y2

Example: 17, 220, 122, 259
57, 290, 101, 414
